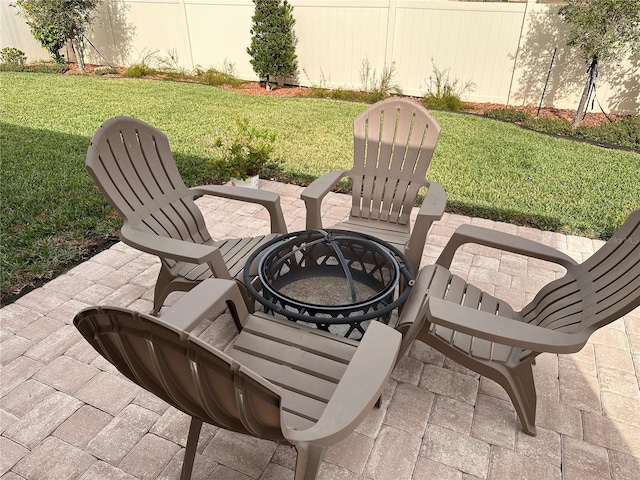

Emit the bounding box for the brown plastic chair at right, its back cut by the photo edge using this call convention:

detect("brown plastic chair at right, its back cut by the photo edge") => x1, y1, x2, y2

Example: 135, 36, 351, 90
397, 209, 640, 435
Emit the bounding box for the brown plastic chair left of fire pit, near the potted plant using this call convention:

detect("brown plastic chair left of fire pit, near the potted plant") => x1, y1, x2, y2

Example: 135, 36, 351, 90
86, 117, 287, 313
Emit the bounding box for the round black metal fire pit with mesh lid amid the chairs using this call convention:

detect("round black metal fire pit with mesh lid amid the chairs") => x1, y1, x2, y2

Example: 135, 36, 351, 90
244, 230, 414, 339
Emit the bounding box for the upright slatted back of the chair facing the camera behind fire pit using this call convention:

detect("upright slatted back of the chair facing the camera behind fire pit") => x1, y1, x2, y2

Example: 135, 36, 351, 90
350, 98, 440, 228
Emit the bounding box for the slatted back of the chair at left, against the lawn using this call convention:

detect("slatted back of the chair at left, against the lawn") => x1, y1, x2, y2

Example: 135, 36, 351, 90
85, 117, 212, 243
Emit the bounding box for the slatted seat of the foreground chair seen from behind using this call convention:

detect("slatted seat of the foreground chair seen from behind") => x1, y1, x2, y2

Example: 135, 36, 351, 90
227, 313, 359, 430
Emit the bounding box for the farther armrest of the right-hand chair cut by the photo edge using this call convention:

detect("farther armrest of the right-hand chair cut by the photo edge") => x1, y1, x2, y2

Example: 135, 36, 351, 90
436, 225, 577, 271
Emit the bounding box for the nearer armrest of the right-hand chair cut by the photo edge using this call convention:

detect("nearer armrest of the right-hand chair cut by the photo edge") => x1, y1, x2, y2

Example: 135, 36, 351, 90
426, 297, 588, 353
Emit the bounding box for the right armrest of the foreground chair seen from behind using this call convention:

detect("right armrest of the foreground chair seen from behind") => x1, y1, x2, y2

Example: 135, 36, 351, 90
282, 321, 401, 447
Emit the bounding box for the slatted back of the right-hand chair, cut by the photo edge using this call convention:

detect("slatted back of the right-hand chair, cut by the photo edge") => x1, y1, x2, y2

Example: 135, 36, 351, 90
522, 209, 640, 348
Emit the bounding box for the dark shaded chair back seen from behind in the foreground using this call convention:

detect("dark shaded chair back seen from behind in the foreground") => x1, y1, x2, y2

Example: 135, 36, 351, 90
73, 307, 284, 440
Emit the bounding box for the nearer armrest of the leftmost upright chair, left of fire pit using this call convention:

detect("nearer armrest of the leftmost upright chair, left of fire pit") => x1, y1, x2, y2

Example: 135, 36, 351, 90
120, 224, 231, 278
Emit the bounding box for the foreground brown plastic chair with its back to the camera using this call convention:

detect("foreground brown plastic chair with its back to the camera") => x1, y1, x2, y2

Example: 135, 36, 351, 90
74, 279, 401, 480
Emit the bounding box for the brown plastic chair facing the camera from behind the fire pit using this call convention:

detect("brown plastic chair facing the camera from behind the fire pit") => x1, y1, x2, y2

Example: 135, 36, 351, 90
301, 98, 447, 272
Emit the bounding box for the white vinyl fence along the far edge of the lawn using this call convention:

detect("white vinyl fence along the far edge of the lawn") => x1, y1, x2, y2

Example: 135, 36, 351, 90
0, 0, 640, 114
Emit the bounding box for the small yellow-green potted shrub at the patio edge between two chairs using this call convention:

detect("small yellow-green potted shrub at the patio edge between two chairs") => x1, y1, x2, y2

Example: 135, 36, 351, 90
214, 118, 277, 180
